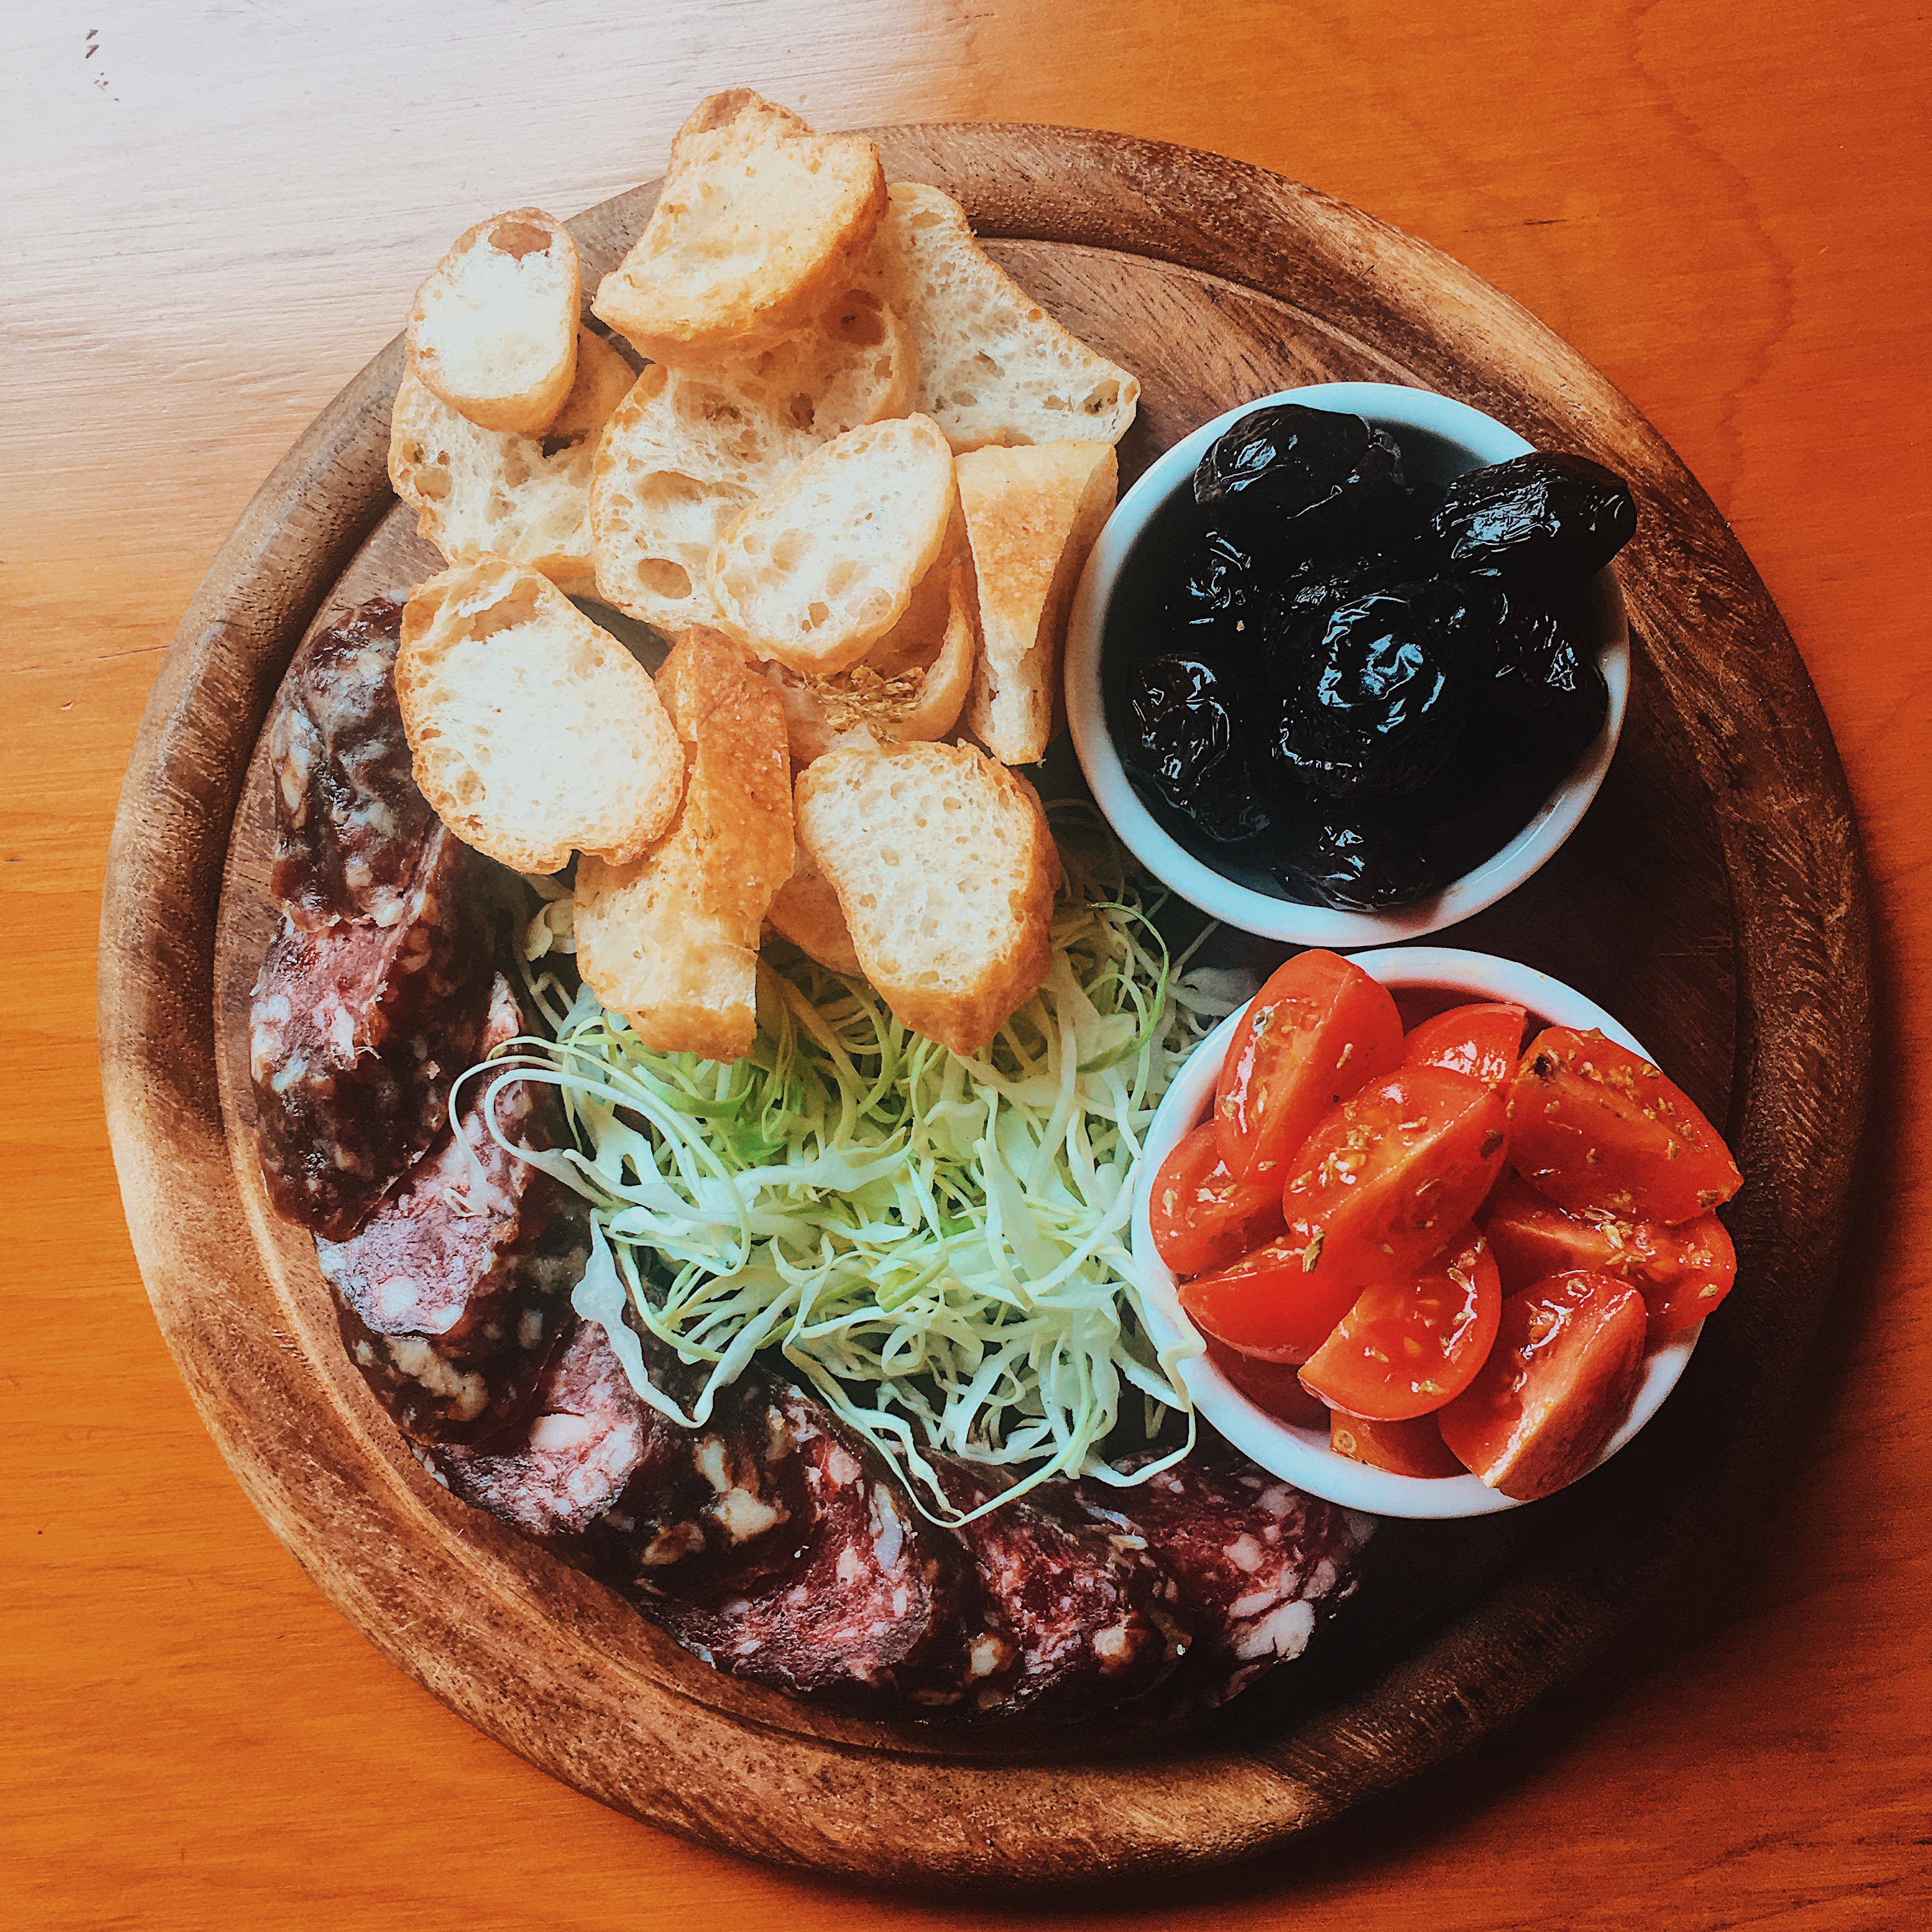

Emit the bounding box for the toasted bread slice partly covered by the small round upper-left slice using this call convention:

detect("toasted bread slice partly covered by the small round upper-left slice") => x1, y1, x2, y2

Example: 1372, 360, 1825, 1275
388, 328, 636, 597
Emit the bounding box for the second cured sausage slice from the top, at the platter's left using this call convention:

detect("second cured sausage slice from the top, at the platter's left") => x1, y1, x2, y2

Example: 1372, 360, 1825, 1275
249, 825, 491, 1240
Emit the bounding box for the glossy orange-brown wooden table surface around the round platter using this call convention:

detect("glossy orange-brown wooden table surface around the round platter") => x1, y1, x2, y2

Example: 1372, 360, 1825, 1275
0, 0, 1932, 1932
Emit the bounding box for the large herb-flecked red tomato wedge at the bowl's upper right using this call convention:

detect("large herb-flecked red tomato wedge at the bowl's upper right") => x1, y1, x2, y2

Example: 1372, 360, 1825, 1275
1509, 1026, 1745, 1223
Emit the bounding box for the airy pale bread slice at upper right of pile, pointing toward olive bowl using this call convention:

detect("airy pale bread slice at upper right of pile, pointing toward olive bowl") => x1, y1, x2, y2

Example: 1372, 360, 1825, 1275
866, 181, 1140, 450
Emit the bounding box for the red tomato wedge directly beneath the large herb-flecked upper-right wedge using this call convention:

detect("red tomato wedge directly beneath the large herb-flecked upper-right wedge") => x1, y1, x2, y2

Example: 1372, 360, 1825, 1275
1483, 1175, 1737, 1349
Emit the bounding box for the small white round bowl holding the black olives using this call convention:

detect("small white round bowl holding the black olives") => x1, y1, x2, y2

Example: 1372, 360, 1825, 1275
1066, 383, 1630, 949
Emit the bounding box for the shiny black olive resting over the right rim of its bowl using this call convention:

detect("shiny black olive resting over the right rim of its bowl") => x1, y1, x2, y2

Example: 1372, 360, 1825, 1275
1428, 450, 1636, 595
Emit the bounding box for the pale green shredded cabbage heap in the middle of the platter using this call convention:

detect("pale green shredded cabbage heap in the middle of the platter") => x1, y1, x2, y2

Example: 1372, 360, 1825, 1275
475, 815, 1244, 1522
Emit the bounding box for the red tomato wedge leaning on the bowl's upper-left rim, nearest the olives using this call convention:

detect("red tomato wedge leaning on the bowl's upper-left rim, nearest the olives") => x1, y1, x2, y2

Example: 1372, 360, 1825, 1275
1213, 951, 1402, 1186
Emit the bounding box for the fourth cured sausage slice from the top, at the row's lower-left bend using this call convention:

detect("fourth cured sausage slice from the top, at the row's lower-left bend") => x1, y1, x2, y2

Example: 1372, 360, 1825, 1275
425, 1321, 661, 1538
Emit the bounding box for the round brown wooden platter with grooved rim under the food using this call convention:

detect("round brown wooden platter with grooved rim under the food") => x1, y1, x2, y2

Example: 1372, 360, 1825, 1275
100, 126, 1870, 1885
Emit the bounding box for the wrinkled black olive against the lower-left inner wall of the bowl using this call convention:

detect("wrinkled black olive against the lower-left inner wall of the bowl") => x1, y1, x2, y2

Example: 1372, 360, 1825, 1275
1121, 653, 1268, 842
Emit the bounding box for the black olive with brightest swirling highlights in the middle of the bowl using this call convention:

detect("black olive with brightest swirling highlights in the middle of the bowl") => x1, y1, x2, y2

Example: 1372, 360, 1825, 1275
1269, 581, 1476, 798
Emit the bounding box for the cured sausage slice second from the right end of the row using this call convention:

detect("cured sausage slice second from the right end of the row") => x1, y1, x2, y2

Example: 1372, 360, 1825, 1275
916, 1462, 1190, 1719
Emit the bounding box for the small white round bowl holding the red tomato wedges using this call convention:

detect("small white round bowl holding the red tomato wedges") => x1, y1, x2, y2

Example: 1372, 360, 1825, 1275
1134, 947, 1704, 1517
